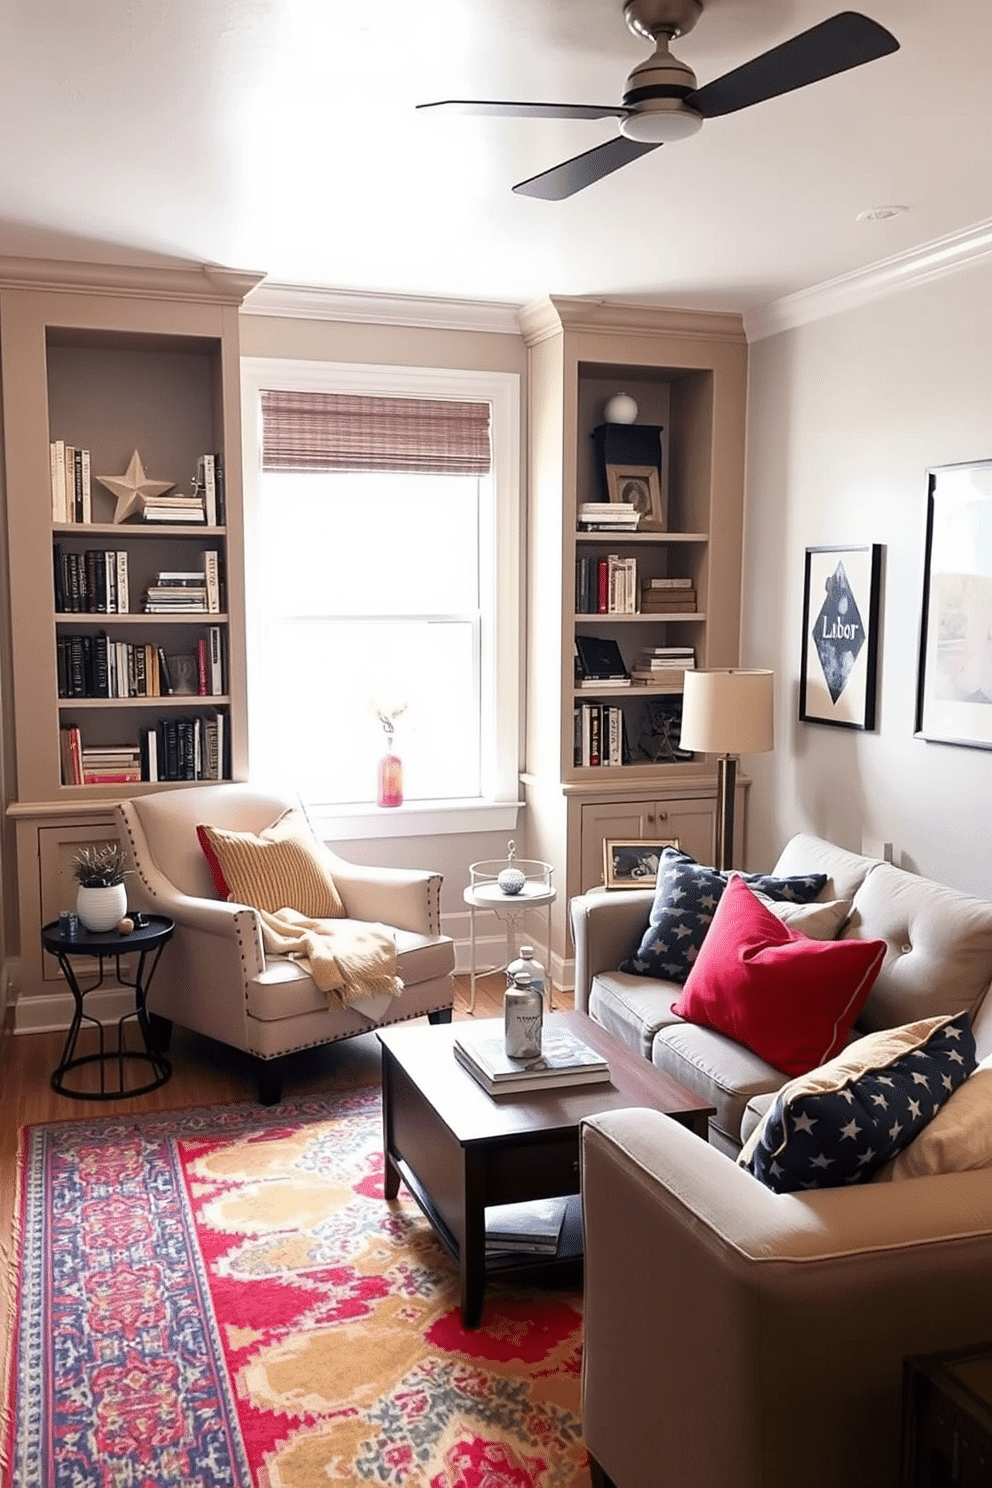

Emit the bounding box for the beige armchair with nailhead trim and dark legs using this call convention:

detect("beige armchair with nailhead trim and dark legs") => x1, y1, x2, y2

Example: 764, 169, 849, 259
116, 784, 455, 1106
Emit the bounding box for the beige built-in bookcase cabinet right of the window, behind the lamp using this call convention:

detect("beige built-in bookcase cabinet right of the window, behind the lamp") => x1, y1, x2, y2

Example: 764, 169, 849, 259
521, 296, 747, 976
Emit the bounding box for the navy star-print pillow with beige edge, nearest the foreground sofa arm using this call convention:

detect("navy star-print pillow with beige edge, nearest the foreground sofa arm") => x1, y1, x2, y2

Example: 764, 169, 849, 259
738, 1013, 976, 1193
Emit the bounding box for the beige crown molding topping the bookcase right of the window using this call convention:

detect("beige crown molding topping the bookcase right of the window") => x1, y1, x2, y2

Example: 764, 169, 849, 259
519, 295, 745, 345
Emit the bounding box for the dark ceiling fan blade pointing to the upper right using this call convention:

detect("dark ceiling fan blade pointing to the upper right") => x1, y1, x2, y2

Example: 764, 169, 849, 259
686, 10, 898, 119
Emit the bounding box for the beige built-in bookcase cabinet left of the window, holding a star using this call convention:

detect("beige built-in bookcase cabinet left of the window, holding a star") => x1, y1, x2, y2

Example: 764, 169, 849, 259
0, 260, 259, 1027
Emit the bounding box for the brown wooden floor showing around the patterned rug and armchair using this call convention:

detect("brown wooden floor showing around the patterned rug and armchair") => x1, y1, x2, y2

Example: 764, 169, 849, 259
0, 972, 573, 1363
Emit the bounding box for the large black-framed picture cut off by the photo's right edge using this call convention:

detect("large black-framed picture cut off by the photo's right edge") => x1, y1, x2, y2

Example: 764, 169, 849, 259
916, 460, 992, 748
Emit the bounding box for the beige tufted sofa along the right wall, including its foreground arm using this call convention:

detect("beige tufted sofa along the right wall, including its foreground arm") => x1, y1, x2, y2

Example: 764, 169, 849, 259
573, 836, 992, 1488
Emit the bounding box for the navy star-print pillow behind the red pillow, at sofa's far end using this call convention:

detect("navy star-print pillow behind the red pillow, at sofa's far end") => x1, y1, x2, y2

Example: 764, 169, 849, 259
620, 847, 827, 982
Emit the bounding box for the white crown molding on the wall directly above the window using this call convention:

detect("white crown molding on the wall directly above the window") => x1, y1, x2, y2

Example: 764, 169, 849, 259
242, 280, 521, 336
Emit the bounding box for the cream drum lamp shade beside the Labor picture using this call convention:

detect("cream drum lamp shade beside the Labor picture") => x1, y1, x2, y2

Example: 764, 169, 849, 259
680, 668, 775, 754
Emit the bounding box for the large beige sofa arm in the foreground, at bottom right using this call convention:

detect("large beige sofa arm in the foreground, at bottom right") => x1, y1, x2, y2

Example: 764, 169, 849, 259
582, 1110, 992, 1488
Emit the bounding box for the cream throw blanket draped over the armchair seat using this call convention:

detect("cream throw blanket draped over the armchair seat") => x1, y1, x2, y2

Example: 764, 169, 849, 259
256, 909, 403, 1018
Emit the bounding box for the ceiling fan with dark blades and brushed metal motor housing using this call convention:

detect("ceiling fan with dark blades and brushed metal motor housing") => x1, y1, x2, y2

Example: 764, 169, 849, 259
416, 0, 898, 201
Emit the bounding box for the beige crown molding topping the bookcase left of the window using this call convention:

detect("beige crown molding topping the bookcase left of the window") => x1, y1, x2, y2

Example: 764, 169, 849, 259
0, 257, 263, 305
